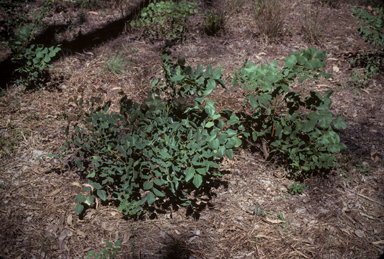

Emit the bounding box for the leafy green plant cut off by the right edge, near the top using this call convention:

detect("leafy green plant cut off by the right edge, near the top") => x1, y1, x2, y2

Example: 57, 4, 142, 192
351, 8, 384, 78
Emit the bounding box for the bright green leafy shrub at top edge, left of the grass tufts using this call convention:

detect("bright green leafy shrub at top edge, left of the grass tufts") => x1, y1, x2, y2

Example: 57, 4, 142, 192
131, 0, 197, 40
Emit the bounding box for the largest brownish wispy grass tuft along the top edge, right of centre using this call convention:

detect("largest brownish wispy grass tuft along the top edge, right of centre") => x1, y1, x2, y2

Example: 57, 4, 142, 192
253, 0, 289, 41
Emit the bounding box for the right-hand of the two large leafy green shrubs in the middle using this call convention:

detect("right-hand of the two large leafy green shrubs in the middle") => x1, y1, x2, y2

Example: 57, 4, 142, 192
231, 48, 347, 176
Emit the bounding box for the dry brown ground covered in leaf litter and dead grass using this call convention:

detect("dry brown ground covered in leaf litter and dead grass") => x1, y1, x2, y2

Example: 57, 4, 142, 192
0, 1, 384, 259
